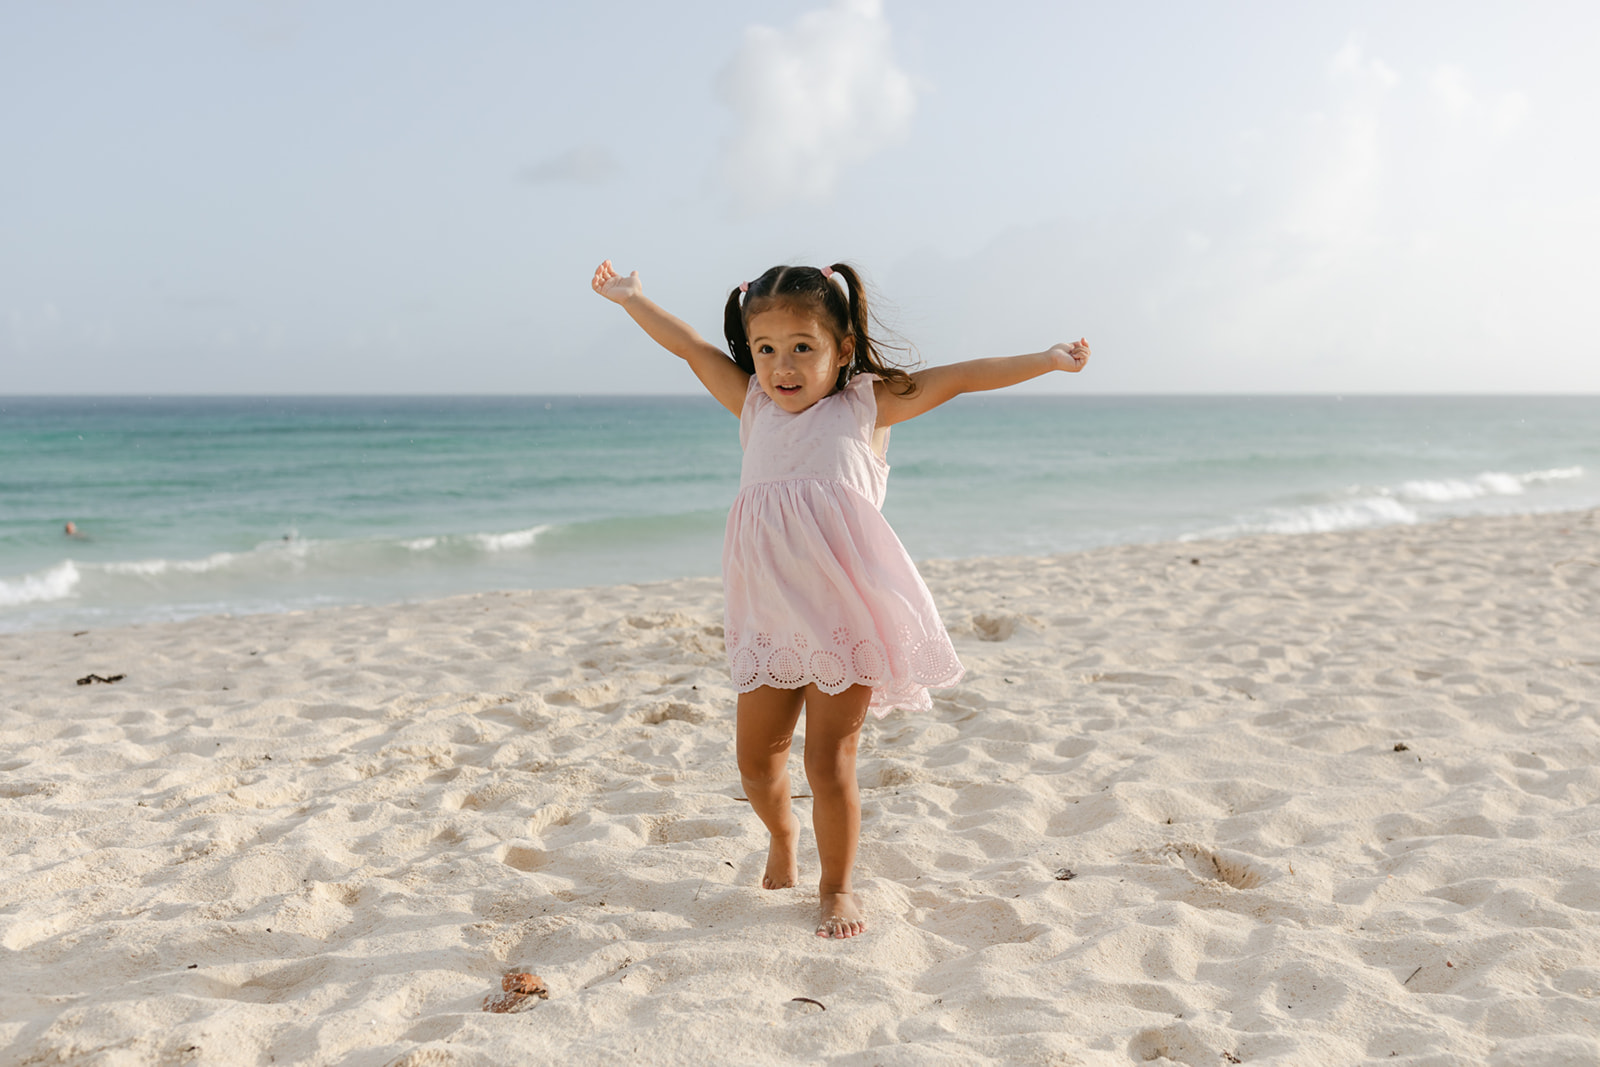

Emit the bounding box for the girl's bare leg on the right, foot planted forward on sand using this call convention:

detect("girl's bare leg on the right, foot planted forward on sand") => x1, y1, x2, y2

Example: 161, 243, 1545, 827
805, 685, 872, 937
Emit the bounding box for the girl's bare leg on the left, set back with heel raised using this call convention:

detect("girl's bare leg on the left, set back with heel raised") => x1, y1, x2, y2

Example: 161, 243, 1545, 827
736, 685, 810, 889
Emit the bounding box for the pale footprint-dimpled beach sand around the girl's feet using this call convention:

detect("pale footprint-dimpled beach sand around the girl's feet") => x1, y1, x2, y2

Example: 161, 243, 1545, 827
0, 512, 1600, 1067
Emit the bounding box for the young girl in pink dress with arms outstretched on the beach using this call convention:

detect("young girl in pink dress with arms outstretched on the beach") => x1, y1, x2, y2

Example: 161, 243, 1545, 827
592, 259, 1090, 937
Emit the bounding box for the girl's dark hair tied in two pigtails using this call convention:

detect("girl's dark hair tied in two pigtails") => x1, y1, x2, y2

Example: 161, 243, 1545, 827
722, 262, 917, 397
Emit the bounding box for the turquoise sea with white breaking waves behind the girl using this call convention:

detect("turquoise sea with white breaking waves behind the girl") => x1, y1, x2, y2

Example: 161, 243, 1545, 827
0, 394, 1600, 630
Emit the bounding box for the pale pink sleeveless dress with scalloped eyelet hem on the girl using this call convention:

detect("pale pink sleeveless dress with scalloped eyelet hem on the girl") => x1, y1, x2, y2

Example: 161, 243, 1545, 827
722, 374, 963, 718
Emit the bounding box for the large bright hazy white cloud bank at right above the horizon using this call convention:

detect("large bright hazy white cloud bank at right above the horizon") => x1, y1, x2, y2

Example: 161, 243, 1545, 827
885, 45, 1600, 392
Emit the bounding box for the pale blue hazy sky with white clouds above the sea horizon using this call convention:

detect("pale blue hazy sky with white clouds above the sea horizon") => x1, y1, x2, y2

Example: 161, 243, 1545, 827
0, 0, 1600, 395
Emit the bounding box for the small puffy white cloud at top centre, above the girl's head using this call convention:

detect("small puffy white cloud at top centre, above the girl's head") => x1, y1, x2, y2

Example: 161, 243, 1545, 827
718, 0, 915, 210
